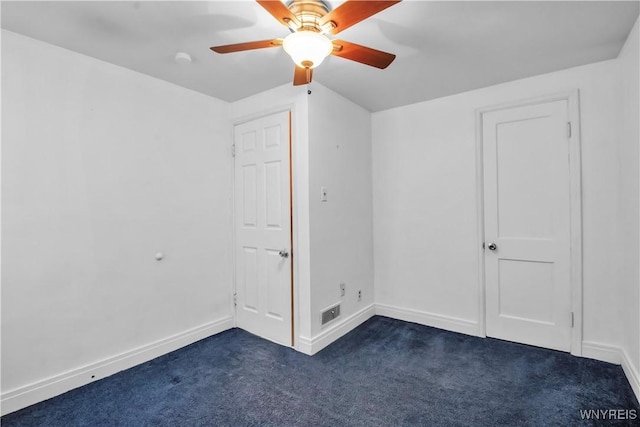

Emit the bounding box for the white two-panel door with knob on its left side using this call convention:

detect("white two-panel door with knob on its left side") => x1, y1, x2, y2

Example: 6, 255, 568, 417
482, 100, 572, 351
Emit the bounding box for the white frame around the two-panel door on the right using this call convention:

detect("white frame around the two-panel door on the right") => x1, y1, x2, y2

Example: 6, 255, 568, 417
476, 89, 582, 356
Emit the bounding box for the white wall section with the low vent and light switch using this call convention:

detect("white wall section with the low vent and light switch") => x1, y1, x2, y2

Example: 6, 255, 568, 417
309, 84, 374, 352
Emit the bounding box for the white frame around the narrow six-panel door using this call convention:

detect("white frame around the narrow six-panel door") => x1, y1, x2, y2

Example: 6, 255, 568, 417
230, 105, 299, 347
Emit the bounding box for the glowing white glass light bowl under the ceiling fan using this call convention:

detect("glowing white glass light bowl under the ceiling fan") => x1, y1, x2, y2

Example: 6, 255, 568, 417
282, 31, 333, 68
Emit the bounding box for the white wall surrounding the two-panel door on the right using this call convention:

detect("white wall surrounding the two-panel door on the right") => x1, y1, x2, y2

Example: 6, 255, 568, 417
373, 60, 637, 346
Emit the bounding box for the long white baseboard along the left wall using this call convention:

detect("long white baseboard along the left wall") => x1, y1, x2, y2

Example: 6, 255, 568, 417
0, 316, 233, 415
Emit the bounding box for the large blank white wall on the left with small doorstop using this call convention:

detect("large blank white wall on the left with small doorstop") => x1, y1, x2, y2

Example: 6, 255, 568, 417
2, 31, 233, 412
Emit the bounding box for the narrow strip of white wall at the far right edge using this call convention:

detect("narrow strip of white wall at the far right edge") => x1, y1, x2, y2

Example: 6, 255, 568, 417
617, 16, 640, 394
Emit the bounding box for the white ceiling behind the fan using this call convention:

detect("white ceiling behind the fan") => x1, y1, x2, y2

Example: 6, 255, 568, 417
1, 0, 639, 111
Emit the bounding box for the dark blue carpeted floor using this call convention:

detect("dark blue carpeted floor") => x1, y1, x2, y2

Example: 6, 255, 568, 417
1, 317, 640, 427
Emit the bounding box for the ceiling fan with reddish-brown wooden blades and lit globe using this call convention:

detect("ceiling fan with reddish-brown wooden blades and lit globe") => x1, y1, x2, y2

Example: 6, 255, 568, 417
211, 0, 401, 86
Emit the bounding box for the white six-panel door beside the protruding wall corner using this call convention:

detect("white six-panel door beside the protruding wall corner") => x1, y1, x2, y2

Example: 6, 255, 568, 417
234, 111, 293, 345
